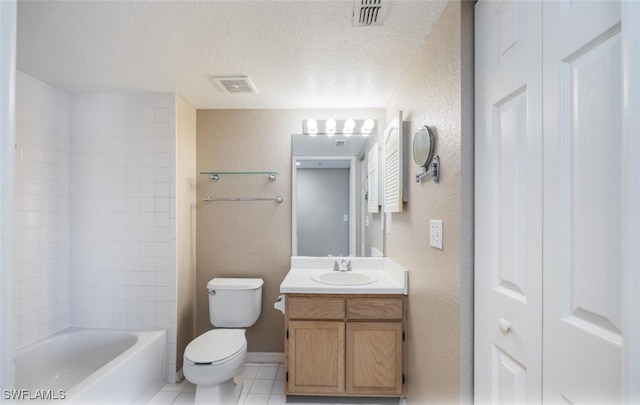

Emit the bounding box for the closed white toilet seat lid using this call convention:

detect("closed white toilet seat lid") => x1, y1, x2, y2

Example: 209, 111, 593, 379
184, 329, 247, 365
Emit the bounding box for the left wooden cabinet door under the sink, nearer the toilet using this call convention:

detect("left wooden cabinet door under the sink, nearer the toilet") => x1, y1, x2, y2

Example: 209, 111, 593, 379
287, 321, 345, 395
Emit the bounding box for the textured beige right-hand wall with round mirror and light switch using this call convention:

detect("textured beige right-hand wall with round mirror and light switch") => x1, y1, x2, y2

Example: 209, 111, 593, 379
385, 1, 473, 404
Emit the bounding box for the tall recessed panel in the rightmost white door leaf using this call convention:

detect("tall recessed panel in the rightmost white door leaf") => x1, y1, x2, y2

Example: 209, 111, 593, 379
559, 26, 622, 338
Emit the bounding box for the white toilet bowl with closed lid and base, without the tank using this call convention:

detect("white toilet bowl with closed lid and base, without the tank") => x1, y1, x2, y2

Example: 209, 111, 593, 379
182, 329, 247, 404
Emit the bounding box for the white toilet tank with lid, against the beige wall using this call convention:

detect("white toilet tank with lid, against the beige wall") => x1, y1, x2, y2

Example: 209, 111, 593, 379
207, 278, 264, 328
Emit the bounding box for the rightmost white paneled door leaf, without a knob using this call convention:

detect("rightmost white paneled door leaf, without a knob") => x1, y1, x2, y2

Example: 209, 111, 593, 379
543, 1, 624, 403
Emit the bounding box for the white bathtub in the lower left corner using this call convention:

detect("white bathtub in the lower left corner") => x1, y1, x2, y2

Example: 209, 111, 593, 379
12, 328, 166, 404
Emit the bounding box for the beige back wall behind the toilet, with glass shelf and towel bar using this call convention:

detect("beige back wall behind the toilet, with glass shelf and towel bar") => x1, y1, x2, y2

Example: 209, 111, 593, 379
195, 109, 384, 352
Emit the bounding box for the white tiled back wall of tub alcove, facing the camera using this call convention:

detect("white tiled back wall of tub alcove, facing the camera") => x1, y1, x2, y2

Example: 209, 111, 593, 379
70, 94, 176, 381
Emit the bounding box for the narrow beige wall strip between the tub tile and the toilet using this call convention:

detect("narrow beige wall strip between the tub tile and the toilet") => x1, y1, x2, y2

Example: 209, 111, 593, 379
175, 96, 196, 371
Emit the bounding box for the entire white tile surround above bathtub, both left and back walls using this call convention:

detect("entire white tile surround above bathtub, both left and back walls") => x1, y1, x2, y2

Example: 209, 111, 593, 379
13, 72, 177, 381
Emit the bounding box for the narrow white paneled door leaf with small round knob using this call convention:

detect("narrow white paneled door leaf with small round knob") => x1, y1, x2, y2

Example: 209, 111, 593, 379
474, 1, 542, 404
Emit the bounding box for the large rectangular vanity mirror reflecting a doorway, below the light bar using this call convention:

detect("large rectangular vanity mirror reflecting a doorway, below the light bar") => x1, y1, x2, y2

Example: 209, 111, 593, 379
291, 134, 383, 256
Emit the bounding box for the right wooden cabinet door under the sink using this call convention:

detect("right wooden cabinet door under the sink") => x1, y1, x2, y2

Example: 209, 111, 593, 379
346, 322, 403, 395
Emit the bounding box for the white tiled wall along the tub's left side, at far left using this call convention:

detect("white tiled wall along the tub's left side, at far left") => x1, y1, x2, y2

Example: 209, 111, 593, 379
13, 72, 70, 347
